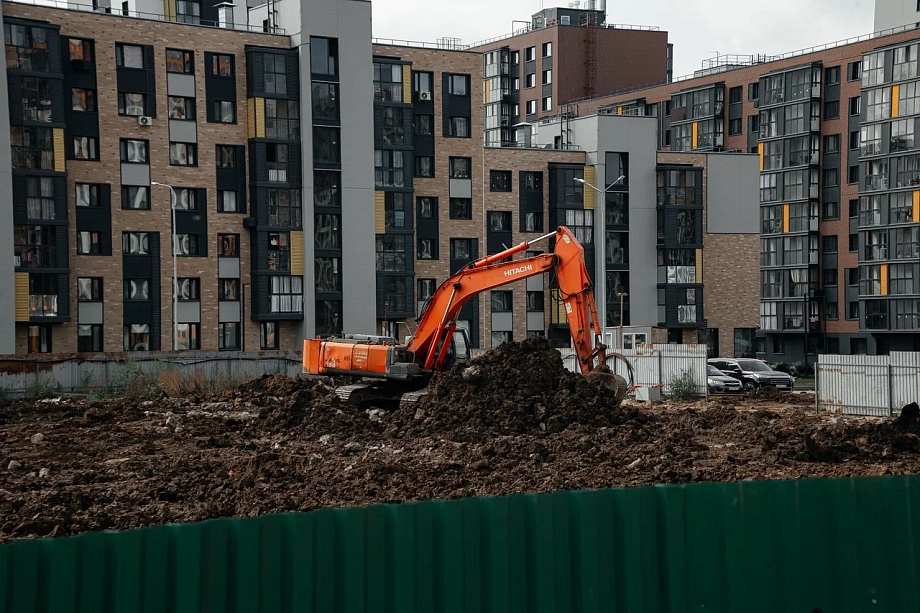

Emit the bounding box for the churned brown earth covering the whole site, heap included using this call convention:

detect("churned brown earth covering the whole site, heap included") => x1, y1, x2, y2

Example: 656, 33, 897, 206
0, 339, 920, 542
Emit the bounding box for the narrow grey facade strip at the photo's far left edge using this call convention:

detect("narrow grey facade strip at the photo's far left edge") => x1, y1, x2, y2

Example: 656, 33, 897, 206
0, 1, 16, 355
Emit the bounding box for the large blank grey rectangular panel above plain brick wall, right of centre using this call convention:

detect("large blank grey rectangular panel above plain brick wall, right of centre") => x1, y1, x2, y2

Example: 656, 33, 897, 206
706, 153, 761, 234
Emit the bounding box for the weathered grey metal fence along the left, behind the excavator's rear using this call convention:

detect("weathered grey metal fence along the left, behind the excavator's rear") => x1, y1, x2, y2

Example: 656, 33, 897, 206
0, 351, 303, 398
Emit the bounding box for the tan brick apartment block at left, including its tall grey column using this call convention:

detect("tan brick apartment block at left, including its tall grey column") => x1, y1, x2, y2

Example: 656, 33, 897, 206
0, 0, 374, 353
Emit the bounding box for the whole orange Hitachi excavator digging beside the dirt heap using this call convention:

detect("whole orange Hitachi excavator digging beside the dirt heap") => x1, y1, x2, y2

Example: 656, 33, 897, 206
303, 226, 632, 408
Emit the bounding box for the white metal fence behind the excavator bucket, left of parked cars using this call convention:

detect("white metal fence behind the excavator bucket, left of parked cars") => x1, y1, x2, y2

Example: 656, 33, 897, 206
560, 345, 709, 396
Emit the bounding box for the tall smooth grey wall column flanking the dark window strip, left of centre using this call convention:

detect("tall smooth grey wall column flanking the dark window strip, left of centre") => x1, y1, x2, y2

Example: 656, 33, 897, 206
300, 0, 377, 337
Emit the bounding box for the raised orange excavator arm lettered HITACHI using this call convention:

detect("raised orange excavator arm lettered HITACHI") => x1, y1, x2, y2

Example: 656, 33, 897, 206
407, 226, 606, 374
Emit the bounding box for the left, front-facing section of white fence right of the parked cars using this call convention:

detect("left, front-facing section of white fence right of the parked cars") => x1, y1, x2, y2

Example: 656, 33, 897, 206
815, 355, 892, 417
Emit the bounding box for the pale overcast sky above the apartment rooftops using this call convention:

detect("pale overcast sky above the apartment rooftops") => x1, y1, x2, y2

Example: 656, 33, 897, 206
372, 0, 874, 77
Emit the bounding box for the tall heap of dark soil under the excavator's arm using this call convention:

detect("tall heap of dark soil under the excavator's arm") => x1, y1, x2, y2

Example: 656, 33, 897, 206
402, 337, 635, 440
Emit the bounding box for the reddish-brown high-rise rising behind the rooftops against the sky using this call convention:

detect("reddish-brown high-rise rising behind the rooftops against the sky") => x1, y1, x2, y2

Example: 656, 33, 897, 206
470, 1, 673, 147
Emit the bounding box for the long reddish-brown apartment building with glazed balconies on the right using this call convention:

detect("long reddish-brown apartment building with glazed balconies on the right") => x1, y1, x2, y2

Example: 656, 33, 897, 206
537, 27, 920, 362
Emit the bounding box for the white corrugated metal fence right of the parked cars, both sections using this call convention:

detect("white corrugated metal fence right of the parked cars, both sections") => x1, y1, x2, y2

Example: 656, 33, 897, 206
815, 351, 920, 417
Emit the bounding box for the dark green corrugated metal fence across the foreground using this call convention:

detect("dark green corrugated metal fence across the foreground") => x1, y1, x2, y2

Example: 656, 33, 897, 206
0, 477, 920, 613
